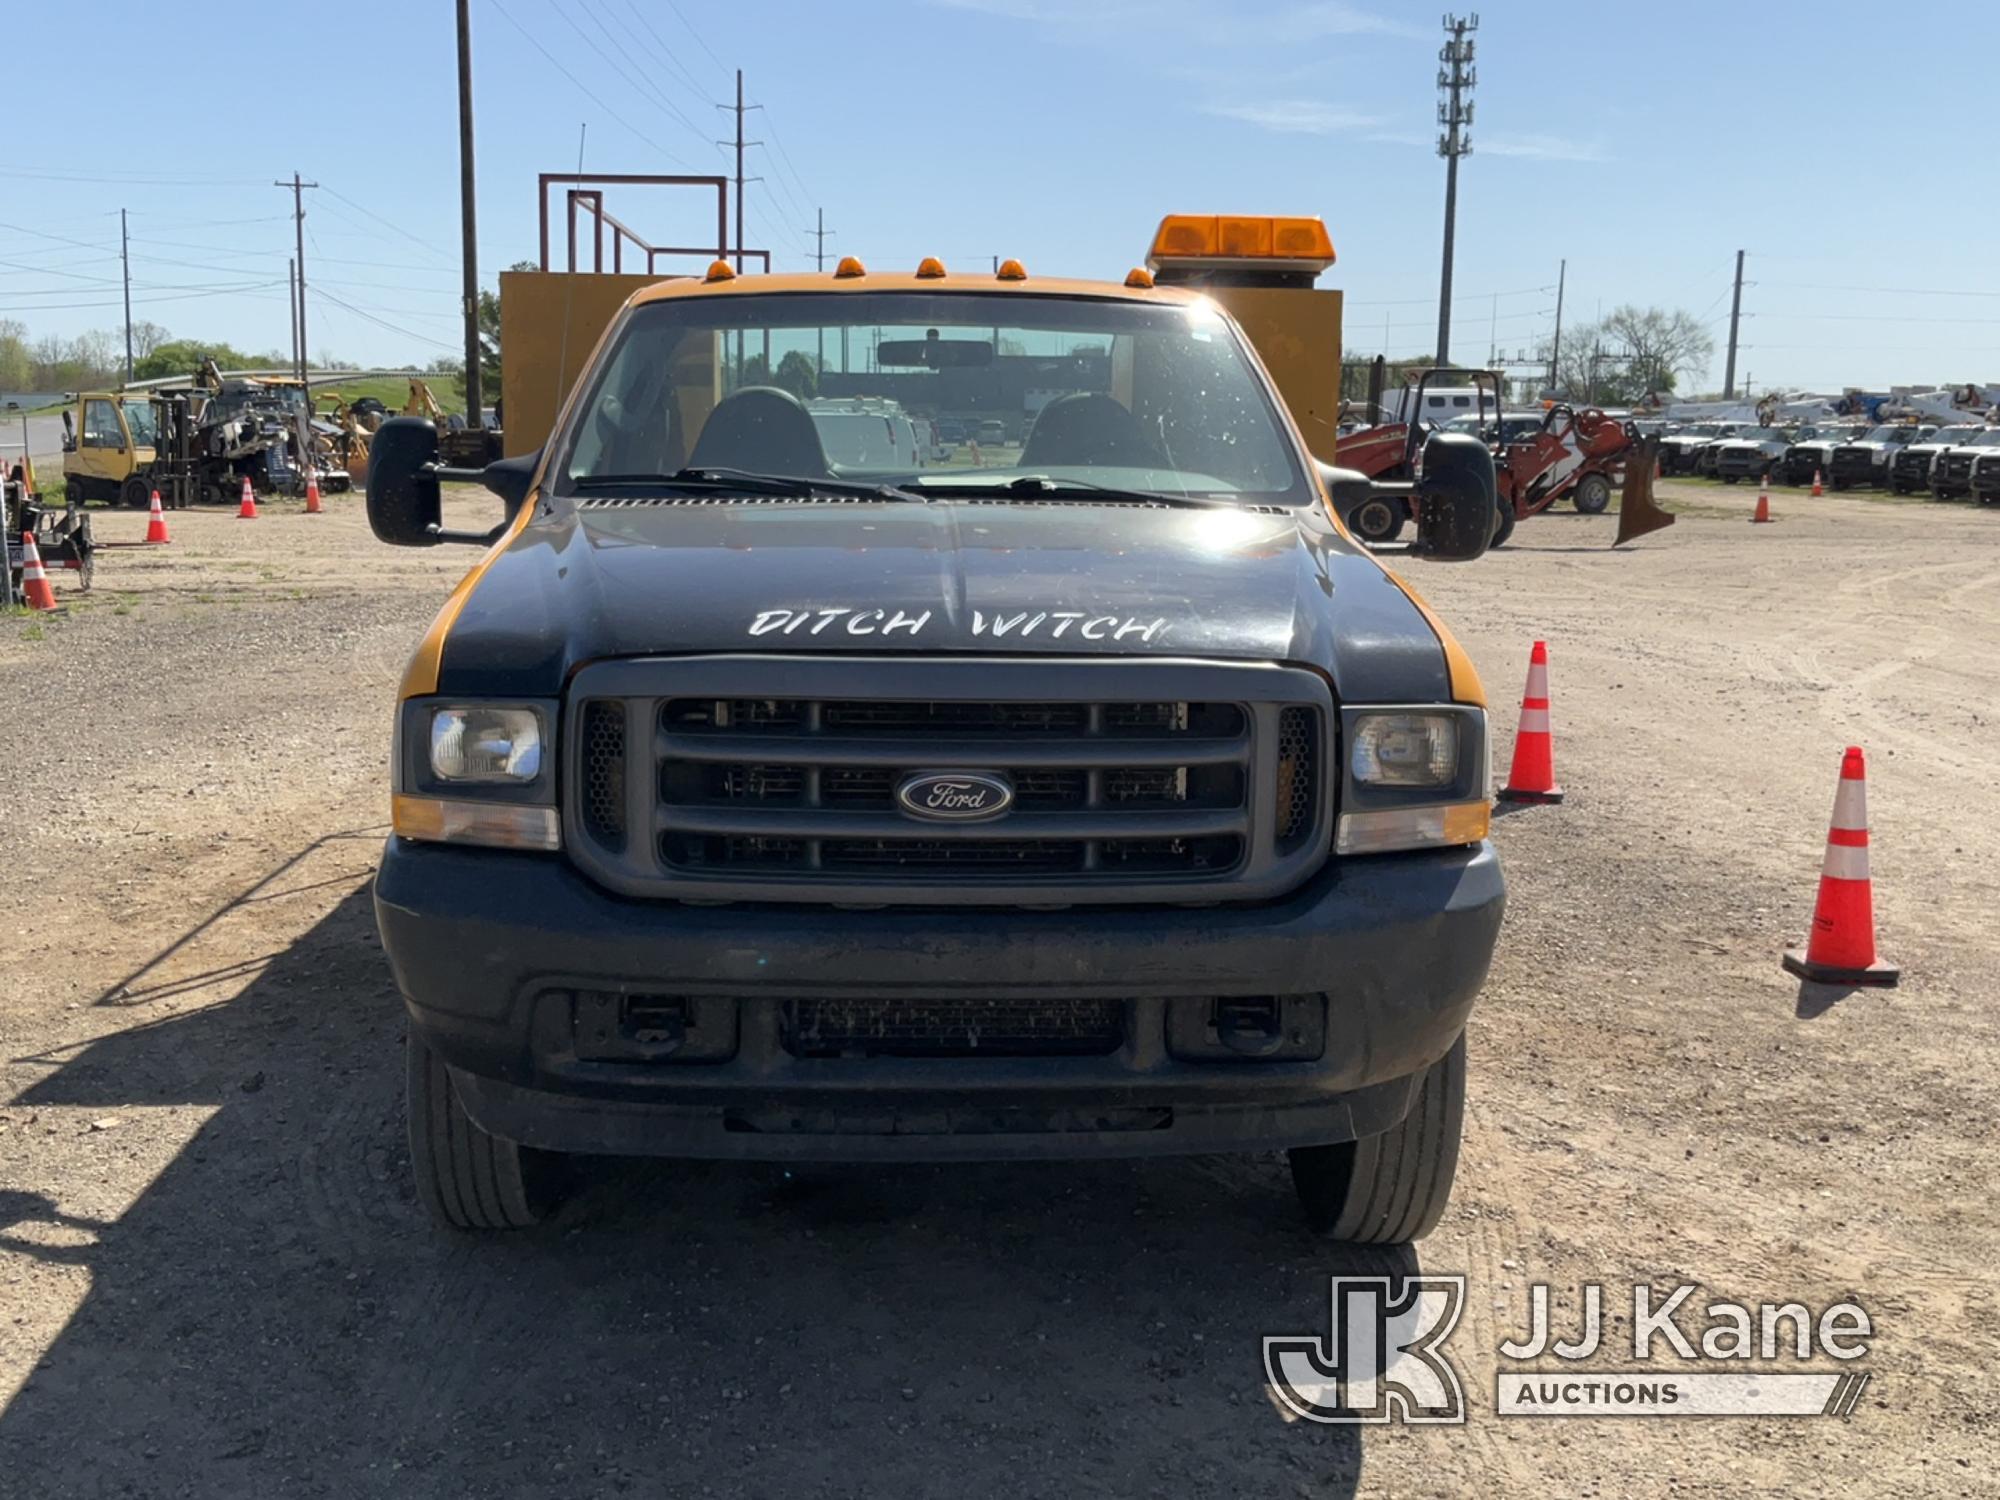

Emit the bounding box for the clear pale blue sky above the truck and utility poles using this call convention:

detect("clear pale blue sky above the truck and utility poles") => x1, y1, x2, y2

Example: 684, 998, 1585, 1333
0, 0, 2000, 388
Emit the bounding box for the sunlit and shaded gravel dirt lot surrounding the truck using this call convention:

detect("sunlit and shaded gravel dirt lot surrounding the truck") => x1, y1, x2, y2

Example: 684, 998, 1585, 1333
0, 486, 2000, 1498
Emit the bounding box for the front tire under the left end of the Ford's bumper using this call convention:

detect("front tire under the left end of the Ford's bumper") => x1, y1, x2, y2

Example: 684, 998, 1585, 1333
404, 1034, 556, 1230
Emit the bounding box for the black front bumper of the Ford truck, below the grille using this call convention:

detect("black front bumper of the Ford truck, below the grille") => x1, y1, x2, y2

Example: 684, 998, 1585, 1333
376, 838, 1504, 1160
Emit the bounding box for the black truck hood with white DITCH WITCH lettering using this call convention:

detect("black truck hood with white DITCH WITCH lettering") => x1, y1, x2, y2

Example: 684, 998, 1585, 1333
438, 496, 1450, 702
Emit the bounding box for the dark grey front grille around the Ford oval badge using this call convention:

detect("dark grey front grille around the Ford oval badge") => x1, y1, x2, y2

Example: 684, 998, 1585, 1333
566, 658, 1332, 904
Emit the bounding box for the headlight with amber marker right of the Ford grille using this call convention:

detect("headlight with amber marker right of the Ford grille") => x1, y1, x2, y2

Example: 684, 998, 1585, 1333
1334, 704, 1492, 854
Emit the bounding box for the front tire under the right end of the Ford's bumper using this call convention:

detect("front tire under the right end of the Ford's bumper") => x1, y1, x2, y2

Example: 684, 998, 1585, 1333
1288, 1034, 1466, 1244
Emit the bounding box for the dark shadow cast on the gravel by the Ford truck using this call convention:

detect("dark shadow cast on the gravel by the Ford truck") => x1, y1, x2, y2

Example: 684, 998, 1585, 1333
0, 888, 1392, 1498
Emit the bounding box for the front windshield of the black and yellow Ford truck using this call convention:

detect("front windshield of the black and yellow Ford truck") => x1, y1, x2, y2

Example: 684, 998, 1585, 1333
556, 292, 1310, 504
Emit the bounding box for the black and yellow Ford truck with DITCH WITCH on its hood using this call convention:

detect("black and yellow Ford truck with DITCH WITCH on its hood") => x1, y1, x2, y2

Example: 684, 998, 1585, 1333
368, 218, 1504, 1242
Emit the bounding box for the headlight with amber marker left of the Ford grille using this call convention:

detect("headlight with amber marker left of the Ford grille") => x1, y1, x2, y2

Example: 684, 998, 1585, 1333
392, 698, 562, 850
